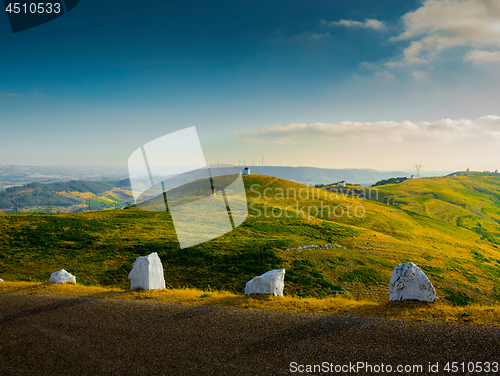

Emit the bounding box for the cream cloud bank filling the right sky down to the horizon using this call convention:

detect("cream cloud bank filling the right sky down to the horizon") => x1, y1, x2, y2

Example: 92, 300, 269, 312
233, 115, 500, 171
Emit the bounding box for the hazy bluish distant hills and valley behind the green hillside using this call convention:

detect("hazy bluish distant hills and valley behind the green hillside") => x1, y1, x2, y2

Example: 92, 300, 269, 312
0, 165, 452, 213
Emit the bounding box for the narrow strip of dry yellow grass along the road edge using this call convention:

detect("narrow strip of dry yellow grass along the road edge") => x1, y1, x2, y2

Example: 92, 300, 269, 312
0, 282, 500, 326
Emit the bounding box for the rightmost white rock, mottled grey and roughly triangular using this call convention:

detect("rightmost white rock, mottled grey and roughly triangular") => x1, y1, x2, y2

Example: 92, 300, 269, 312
389, 262, 436, 302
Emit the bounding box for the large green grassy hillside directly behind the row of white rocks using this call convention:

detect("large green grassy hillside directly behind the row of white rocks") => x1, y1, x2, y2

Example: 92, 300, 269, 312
0, 175, 500, 304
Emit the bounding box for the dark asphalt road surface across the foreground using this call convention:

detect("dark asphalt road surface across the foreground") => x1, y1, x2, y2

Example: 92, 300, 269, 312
0, 294, 500, 375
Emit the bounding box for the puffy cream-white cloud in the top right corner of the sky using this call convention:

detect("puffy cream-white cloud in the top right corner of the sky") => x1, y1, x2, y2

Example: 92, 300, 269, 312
388, 0, 500, 67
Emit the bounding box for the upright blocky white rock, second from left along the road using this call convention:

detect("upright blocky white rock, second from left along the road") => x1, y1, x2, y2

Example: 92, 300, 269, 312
128, 252, 165, 290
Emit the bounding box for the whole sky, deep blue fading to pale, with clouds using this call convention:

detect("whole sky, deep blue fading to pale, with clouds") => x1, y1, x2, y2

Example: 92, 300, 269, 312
0, 0, 500, 171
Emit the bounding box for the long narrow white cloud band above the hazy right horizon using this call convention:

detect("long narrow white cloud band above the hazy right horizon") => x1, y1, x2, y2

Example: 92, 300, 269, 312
233, 115, 500, 143
